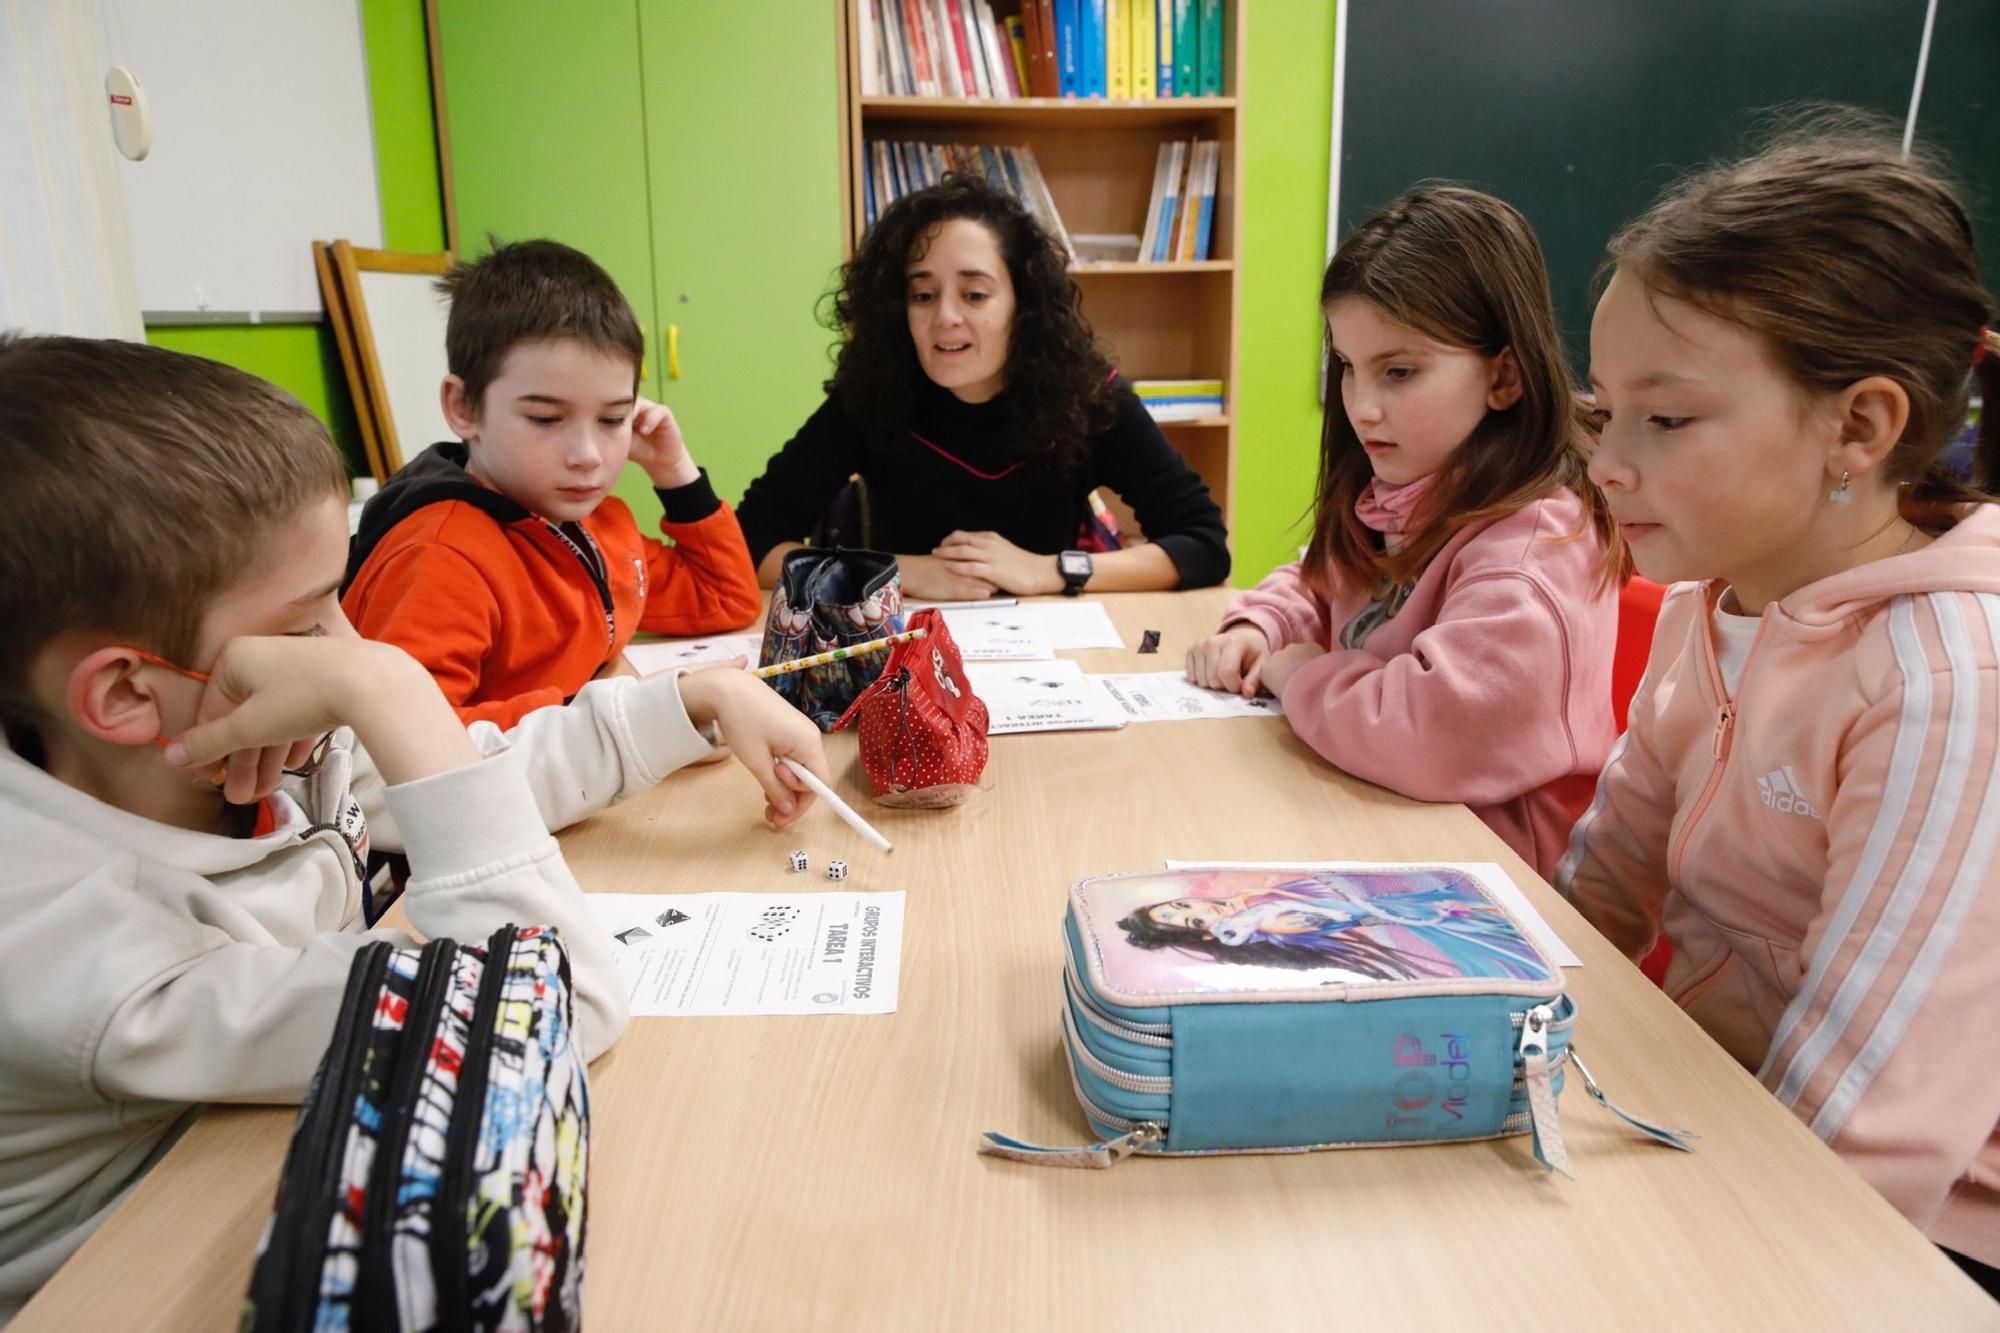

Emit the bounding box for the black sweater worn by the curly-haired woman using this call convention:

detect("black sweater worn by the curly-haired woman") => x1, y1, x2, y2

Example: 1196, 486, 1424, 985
736, 370, 1230, 588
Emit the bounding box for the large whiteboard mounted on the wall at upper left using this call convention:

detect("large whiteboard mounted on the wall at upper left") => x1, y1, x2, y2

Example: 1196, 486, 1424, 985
104, 0, 382, 322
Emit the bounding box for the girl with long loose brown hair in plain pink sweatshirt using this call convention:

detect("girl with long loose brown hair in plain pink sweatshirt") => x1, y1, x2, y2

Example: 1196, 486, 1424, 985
1188, 186, 1620, 875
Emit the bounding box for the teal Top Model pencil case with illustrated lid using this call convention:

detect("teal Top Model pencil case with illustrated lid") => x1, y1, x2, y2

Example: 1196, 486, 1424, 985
980, 865, 1692, 1175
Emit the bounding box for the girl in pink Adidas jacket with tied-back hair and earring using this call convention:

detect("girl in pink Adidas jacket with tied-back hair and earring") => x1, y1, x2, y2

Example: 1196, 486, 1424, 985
1558, 118, 2000, 1291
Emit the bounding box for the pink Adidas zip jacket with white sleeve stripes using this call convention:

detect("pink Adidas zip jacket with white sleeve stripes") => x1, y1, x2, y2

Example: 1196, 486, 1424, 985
1558, 504, 2000, 1265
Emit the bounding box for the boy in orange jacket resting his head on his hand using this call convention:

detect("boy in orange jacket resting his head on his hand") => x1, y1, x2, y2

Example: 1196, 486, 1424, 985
342, 240, 762, 727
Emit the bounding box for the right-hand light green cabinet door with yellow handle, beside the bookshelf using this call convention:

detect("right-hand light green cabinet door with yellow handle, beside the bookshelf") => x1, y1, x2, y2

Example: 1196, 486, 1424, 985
640, 0, 842, 502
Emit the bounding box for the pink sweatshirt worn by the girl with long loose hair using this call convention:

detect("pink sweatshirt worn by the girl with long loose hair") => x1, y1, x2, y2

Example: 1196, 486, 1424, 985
1222, 490, 1618, 875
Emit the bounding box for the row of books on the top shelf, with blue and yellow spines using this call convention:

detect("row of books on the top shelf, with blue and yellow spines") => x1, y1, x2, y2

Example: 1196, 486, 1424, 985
858, 0, 1230, 100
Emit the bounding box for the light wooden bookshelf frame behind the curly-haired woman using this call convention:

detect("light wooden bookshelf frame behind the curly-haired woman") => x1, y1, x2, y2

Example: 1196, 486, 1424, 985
836, 0, 1248, 532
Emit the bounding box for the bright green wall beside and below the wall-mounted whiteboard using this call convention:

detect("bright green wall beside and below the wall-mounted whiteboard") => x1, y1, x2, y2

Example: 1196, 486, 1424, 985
146, 0, 444, 472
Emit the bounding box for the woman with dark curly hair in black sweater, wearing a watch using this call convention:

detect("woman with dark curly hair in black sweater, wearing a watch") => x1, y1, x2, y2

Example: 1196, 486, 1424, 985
738, 174, 1230, 598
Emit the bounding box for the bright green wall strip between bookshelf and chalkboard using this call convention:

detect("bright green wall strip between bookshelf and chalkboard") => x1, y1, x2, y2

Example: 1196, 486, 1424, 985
1234, 0, 1334, 586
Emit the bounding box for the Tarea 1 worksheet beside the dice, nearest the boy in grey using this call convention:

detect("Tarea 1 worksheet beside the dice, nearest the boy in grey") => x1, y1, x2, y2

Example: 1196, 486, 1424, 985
584, 891, 902, 1017
